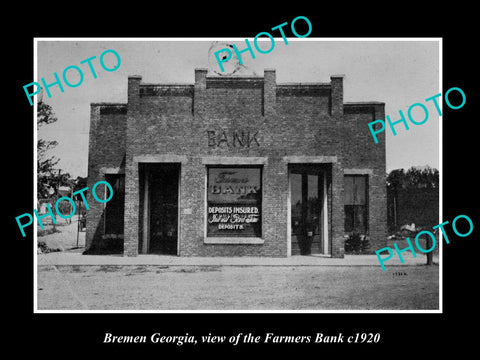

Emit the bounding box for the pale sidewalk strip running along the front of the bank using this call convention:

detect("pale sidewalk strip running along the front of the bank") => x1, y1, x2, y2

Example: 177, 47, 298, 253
37, 251, 439, 268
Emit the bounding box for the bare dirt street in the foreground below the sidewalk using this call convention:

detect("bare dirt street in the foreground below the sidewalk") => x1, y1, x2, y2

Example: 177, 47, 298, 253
37, 265, 439, 310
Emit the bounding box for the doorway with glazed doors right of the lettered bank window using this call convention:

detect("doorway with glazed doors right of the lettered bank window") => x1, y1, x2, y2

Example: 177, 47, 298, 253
289, 164, 330, 255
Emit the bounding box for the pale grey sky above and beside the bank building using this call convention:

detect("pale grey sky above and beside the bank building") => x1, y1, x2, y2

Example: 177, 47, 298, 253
35, 38, 441, 178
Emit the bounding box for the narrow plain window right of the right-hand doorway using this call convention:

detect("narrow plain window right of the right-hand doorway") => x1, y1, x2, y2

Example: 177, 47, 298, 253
344, 175, 368, 234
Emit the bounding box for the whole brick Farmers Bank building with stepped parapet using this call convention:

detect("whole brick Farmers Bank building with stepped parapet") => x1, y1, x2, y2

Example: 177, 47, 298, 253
86, 69, 387, 257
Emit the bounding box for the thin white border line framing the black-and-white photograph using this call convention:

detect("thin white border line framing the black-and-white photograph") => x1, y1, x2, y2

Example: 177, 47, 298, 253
33, 37, 443, 314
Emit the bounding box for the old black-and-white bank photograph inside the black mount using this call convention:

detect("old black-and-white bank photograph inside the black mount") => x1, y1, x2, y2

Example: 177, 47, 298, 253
31, 38, 440, 313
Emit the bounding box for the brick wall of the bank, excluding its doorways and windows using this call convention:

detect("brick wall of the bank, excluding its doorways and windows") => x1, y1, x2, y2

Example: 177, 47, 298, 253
87, 69, 386, 257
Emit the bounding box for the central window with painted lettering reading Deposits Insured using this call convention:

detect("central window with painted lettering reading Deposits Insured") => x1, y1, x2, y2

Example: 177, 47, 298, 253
207, 166, 262, 237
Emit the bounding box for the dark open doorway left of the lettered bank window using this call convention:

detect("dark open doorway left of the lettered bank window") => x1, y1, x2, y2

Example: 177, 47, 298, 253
142, 163, 180, 255
